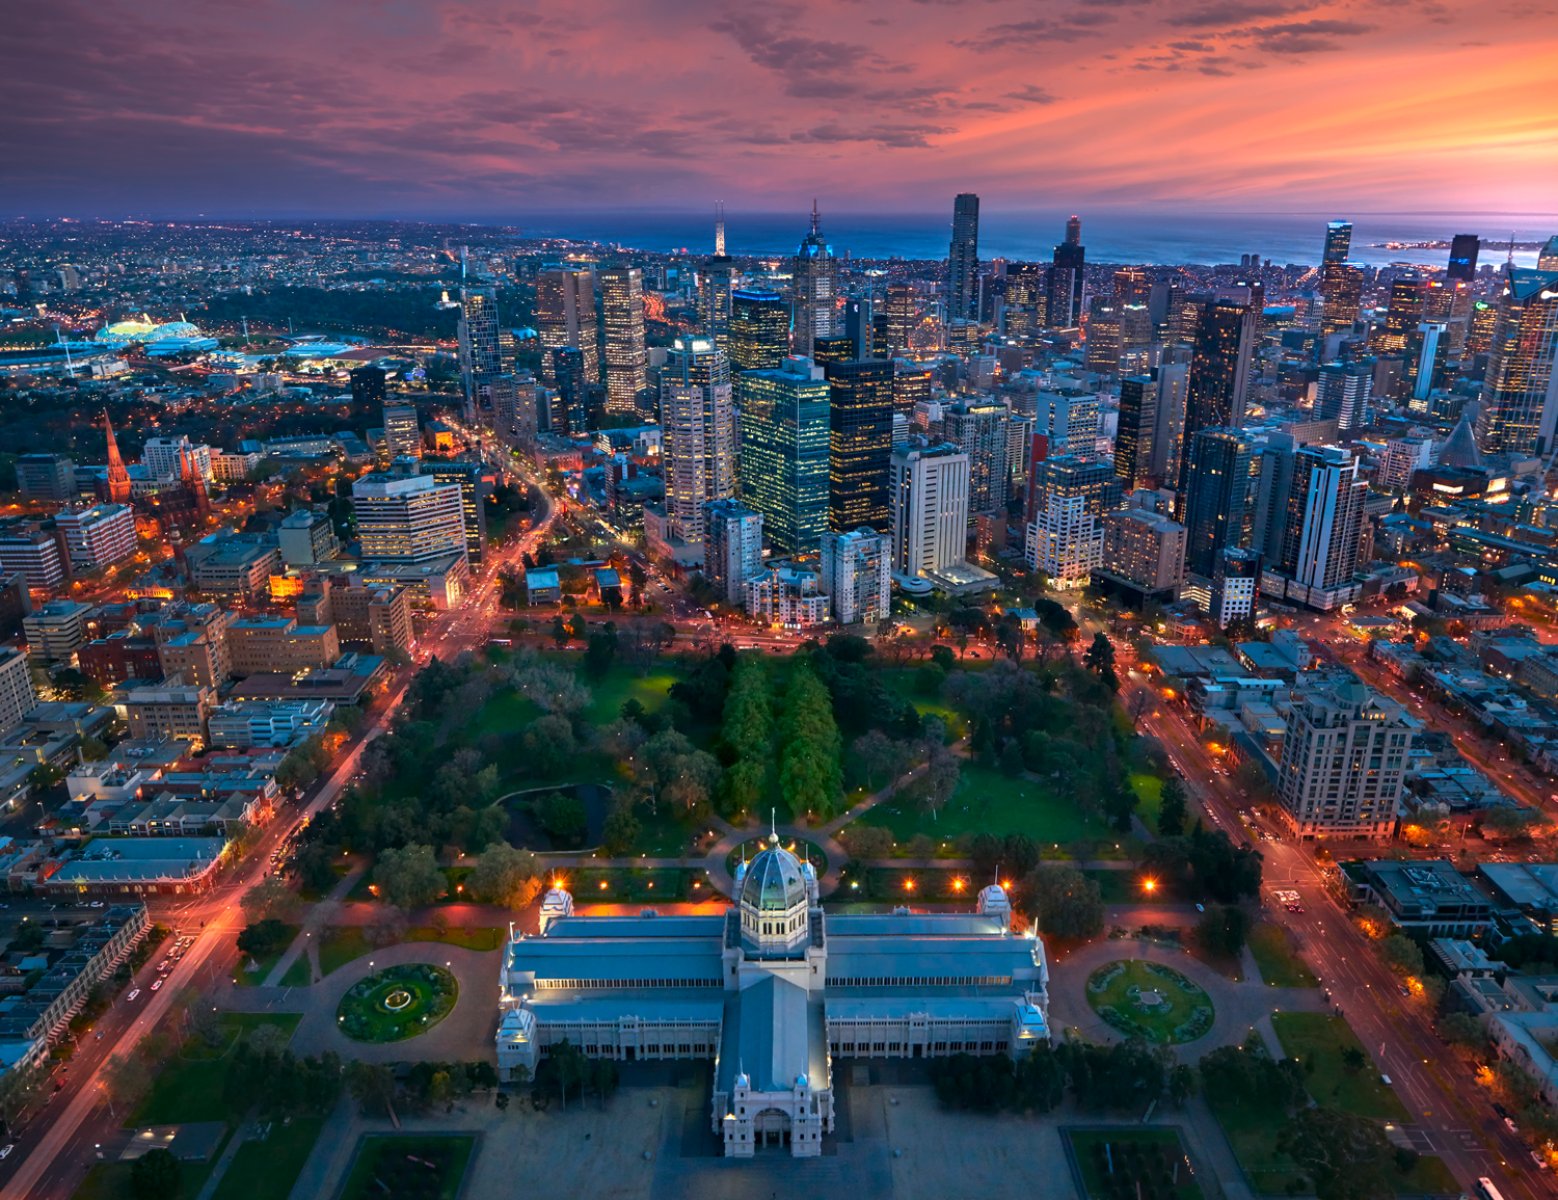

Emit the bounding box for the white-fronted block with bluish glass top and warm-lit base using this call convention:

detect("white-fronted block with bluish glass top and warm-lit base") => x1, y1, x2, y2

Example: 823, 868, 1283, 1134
1025, 455, 1123, 588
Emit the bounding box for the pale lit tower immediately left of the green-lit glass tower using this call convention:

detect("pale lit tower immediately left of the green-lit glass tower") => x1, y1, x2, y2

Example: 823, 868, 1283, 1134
661, 337, 735, 542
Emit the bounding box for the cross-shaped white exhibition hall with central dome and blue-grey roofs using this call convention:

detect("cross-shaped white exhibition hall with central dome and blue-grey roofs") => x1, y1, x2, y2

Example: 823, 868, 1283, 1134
497, 835, 1050, 1156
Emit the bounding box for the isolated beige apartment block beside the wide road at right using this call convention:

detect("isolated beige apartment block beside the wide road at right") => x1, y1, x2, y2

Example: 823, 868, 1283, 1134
1278, 679, 1416, 842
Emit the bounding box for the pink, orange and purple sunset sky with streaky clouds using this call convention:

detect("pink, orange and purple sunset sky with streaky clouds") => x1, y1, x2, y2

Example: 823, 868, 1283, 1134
0, 0, 1558, 218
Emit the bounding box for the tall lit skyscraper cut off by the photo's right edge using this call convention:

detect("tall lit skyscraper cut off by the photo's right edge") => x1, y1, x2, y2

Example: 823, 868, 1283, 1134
1479, 266, 1558, 454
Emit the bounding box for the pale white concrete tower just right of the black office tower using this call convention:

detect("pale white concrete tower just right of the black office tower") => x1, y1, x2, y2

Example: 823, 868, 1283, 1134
890, 439, 969, 578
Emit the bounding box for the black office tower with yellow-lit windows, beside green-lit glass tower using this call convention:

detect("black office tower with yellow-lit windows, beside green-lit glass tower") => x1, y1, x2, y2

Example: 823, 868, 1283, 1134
827, 358, 893, 533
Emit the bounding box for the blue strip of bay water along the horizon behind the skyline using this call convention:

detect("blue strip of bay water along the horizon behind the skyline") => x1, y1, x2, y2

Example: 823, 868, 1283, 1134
511, 204, 1558, 266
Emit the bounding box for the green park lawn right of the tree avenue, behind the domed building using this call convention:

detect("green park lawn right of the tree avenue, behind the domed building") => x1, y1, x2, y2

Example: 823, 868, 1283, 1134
862, 764, 1117, 846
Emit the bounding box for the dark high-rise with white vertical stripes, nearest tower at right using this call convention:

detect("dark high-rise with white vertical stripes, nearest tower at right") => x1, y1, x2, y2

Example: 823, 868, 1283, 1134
1260, 446, 1368, 609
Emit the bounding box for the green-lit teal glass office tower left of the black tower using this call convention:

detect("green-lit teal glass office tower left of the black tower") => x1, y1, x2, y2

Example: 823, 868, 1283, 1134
735, 358, 830, 555
